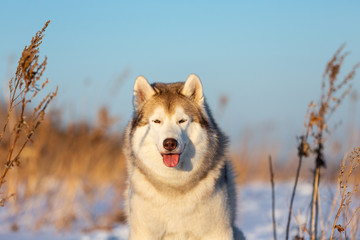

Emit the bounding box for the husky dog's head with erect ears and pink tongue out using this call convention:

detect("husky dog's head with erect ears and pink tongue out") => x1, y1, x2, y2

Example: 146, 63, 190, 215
131, 74, 211, 176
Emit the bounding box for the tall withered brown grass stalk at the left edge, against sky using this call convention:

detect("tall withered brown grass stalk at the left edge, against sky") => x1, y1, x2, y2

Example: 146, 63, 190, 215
0, 21, 57, 205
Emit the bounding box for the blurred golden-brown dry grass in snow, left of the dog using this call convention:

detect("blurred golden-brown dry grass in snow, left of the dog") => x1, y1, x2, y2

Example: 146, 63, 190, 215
0, 110, 125, 229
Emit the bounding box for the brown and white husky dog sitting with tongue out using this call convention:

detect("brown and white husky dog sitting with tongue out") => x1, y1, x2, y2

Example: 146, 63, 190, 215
124, 74, 244, 240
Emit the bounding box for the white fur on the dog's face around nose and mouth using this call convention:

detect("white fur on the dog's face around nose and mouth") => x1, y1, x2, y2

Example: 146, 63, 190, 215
132, 107, 208, 185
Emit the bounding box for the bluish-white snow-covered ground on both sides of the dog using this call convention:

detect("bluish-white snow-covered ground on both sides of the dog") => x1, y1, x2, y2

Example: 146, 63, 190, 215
0, 182, 360, 240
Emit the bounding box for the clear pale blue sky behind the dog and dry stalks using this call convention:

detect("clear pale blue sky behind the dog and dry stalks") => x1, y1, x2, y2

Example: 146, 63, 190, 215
0, 0, 360, 146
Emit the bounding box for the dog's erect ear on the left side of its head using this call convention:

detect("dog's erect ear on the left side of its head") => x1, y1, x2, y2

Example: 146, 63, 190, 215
134, 76, 155, 110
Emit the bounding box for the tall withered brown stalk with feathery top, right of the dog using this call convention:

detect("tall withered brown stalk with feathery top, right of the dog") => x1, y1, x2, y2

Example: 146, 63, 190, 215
305, 45, 360, 240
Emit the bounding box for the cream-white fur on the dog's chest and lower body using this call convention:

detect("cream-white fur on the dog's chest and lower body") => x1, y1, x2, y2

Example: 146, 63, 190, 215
130, 171, 233, 240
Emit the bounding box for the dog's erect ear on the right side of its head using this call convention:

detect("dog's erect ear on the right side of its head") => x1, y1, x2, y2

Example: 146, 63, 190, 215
181, 74, 204, 105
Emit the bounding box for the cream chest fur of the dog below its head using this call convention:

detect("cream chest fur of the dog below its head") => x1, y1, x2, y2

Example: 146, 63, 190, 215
129, 162, 231, 240
